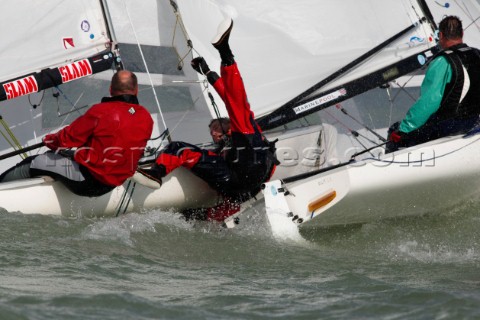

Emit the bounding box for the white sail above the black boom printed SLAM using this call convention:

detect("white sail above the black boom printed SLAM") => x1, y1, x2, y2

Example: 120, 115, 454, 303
0, 0, 111, 83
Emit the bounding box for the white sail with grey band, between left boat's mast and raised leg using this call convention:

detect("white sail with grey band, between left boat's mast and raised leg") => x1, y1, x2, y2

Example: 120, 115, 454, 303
107, 0, 216, 143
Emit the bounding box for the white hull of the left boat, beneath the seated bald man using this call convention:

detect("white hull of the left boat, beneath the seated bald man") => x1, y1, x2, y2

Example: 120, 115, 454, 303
0, 168, 220, 217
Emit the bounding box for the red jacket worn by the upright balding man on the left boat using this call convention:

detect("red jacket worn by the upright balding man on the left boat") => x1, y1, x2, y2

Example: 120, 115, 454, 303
44, 96, 153, 186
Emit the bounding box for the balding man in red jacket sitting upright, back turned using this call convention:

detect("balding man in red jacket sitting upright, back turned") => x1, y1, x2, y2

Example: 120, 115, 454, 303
0, 70, 153, 196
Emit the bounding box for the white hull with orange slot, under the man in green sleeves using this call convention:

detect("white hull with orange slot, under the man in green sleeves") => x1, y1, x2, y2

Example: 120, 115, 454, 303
264, 135, 480, 232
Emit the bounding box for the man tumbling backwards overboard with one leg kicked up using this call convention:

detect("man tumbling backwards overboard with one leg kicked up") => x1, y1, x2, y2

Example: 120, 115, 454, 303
144, 19, 276, 221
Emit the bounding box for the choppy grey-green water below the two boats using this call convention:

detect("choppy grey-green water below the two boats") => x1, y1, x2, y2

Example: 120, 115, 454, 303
0, 196, 480, 319
